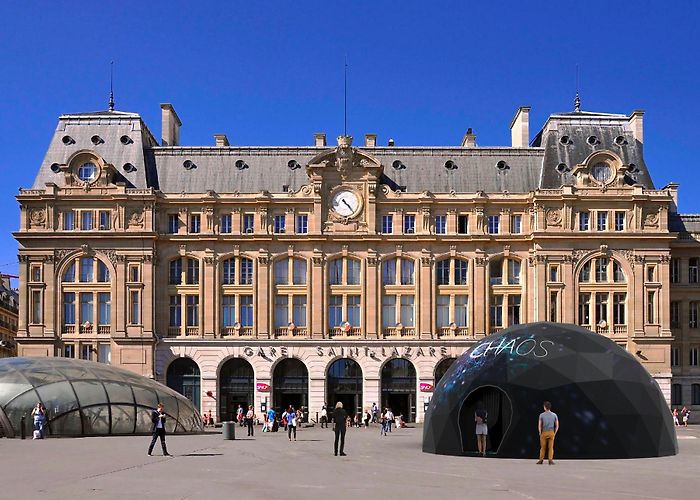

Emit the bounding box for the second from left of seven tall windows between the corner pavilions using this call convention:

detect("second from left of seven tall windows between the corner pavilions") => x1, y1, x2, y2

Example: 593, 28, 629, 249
219, 257, 253, 336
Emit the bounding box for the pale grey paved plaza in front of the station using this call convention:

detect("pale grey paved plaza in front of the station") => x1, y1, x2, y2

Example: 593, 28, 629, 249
0, 426, 700, 500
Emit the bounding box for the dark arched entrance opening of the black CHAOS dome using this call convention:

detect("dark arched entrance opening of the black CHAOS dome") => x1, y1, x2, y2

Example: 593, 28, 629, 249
459, 386, 516, 453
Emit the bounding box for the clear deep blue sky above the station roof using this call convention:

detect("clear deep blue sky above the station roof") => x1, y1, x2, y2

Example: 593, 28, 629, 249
0, 0, 700, 273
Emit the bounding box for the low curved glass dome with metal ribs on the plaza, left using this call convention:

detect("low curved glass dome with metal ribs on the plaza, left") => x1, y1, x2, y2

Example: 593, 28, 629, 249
0, 358, 203, 437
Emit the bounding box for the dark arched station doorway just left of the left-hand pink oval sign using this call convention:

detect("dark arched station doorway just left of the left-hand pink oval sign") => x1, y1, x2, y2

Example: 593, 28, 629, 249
219, 358, 255, 422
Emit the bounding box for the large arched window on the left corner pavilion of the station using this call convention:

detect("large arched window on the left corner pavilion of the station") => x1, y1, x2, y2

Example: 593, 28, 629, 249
61, 256, 112, 338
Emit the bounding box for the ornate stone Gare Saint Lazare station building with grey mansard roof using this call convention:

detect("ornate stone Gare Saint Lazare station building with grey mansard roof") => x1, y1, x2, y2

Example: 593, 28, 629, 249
10, 98, 700, 421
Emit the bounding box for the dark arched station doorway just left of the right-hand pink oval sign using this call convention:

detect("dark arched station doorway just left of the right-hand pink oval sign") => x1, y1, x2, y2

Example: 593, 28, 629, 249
382, 358, 416, 422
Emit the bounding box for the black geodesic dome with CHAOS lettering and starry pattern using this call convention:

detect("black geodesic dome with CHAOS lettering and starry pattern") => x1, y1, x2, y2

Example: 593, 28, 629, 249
423, 322, 678, 458
